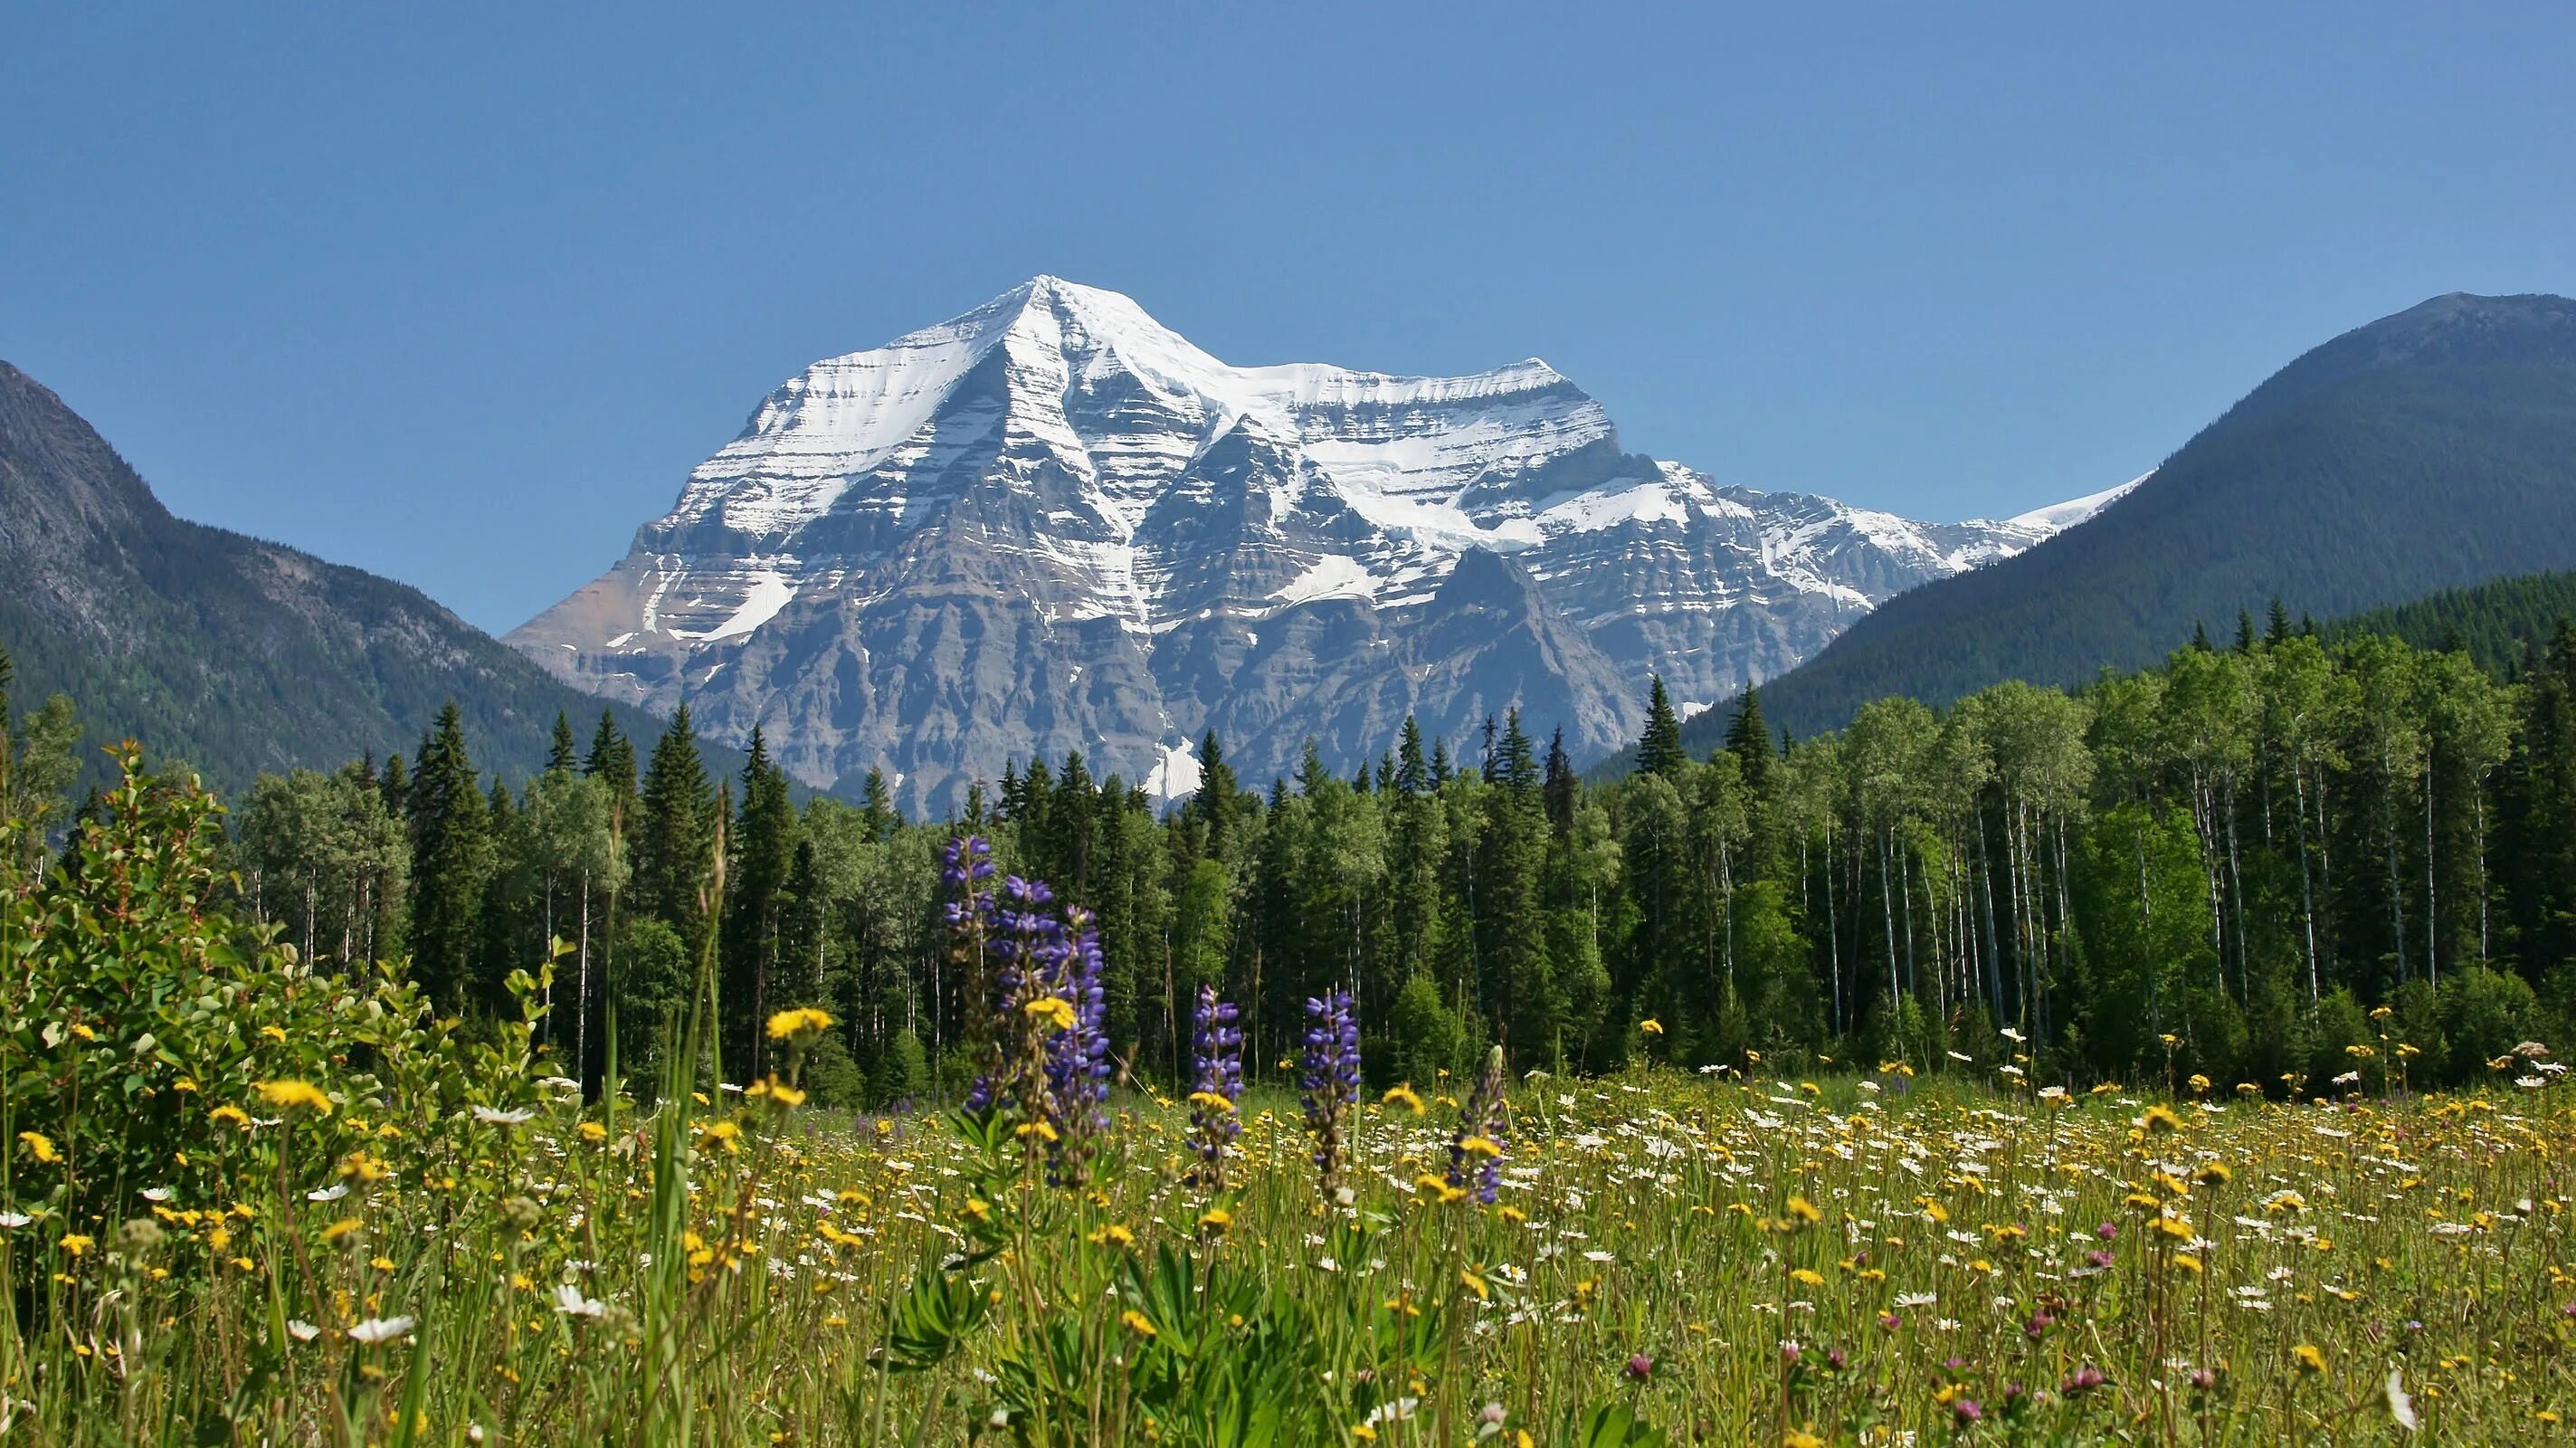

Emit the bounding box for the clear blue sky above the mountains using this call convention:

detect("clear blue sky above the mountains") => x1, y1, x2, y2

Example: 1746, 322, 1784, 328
0, 3, 2576, 632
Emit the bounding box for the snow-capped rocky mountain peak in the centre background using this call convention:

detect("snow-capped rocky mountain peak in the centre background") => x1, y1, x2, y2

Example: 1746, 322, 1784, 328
510, 276, 2120, 809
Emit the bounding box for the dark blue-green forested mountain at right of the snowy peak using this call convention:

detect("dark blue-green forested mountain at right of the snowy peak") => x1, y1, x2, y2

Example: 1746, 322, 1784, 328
1685, 294, 2576, 748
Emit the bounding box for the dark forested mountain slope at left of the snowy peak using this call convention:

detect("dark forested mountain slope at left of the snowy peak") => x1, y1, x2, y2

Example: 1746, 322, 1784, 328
0, 363, 695, 791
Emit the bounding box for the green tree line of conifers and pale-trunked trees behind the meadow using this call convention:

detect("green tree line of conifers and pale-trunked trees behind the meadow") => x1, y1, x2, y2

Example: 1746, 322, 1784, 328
0, 597, 2576, 1105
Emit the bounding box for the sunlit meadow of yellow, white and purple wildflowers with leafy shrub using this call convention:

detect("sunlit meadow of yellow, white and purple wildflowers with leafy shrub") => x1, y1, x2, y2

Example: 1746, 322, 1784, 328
0, 770, 2576, 1448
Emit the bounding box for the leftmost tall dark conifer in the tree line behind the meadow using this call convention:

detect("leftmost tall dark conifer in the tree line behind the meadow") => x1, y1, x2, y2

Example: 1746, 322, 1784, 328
406, 700, 492, 1015
